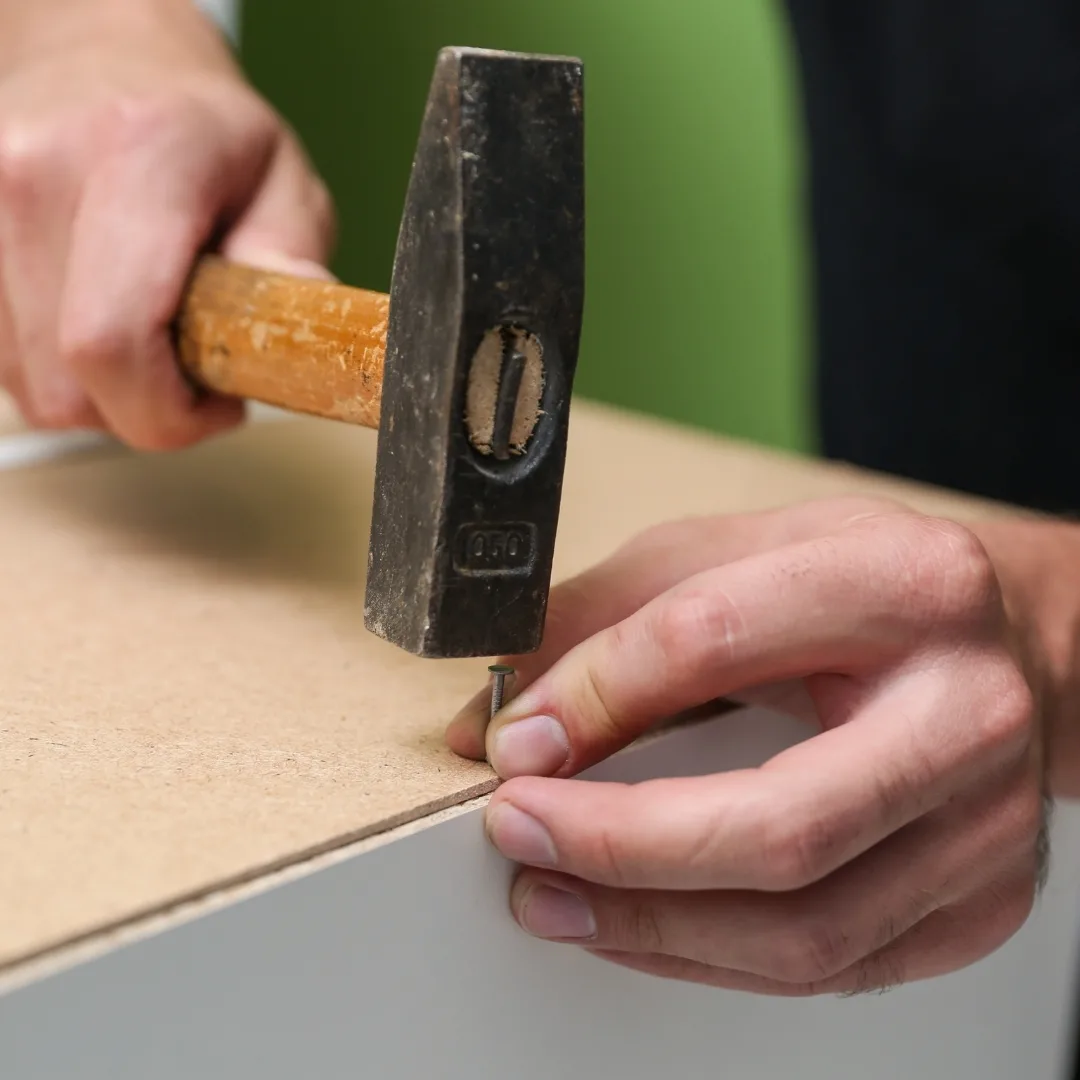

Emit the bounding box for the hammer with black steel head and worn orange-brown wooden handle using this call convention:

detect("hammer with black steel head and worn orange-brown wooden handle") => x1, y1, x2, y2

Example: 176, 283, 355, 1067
176, 49, 584, 658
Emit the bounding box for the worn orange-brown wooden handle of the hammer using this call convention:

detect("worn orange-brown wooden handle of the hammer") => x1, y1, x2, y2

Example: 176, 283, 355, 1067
177, 256, 390, 428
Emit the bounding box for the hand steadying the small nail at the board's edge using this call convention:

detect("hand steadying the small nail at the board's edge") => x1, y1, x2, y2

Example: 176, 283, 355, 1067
448, 500, 1044, 995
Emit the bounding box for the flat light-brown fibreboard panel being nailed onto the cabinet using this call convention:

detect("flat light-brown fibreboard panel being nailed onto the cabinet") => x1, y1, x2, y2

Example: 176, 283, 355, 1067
0, 403, 1006, 968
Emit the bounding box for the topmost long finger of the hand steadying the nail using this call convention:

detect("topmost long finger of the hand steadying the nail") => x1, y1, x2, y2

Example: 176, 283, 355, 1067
487, 514, 1003, 779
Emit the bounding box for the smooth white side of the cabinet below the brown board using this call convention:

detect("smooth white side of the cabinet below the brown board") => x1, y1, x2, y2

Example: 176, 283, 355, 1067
6, 712, 1080, 1080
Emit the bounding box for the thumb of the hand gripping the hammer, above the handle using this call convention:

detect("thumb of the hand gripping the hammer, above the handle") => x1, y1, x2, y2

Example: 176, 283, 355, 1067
221, 131, 337, 281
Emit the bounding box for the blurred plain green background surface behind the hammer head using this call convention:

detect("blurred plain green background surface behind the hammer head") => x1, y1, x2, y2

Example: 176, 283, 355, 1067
241, 0, 813, 450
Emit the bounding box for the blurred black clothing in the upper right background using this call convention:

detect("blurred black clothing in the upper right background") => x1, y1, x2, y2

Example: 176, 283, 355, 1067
787, 0, 1080, 511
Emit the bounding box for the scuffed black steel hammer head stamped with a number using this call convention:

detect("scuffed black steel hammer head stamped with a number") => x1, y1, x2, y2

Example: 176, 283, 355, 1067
365, 49, 584, 657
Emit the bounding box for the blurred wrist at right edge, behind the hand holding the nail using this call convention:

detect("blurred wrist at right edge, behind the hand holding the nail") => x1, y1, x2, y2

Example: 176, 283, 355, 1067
975, 521, 1080, 798
